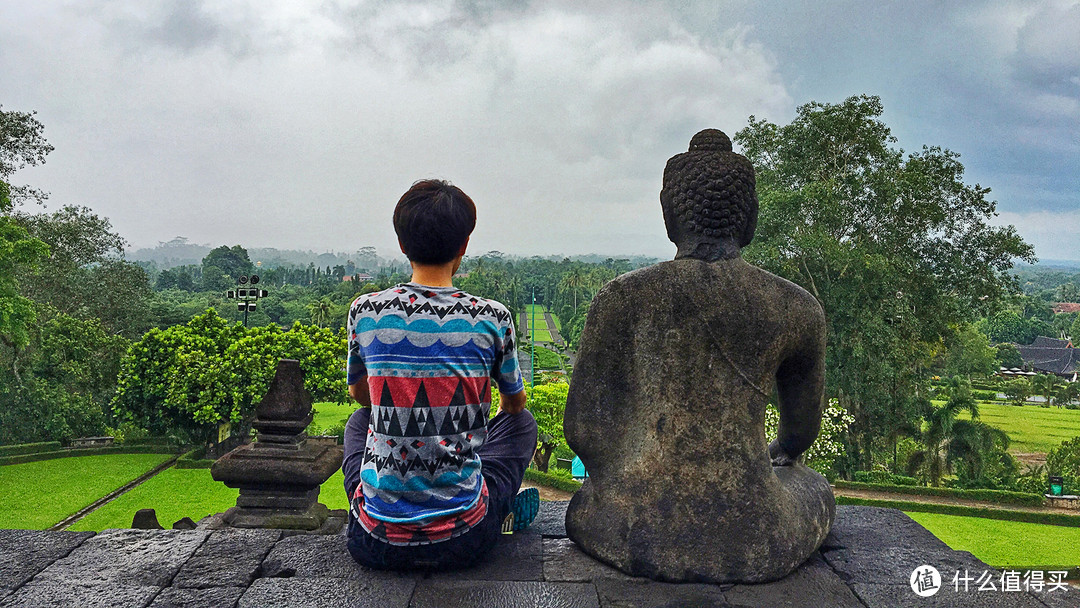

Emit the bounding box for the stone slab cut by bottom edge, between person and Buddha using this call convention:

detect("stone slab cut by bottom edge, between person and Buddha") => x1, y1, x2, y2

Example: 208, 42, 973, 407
410, 580, 599, 608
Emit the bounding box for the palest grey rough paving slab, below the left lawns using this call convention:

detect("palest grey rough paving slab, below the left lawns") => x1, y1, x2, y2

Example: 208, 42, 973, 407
33, 529, 207, 587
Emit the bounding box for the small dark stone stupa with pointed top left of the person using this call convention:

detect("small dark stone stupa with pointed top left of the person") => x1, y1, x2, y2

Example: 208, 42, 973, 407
211, 359, 342, 530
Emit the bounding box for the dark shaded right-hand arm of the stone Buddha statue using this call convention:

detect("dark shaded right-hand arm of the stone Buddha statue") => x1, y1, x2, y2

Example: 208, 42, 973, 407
769, 301, 825, 465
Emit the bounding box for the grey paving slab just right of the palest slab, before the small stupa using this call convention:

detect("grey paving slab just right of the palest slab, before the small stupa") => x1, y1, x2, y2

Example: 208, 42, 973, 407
173, 529, 281, 597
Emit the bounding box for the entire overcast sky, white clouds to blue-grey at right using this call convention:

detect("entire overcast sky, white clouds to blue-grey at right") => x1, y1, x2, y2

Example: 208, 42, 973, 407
0, 0, 1080, 259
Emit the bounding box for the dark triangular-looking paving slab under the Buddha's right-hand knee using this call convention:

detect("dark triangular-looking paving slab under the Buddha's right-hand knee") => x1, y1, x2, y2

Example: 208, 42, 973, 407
724, 554, 862, 608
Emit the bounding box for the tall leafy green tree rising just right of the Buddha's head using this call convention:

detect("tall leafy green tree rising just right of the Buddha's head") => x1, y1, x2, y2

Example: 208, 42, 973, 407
735, 96, 1035, 469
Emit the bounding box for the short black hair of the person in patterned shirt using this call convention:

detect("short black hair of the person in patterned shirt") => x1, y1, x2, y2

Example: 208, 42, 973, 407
394, 179, 476, 265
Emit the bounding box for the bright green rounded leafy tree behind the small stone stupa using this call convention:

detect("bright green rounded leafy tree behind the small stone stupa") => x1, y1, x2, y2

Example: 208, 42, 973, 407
113, 309, 347, 440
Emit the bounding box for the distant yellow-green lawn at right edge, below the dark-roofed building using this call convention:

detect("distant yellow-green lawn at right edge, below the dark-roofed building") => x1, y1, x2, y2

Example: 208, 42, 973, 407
961, 402, 1080, 454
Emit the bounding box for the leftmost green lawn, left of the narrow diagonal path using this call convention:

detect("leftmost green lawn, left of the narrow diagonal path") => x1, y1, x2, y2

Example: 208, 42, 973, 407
0, 454, 172, 530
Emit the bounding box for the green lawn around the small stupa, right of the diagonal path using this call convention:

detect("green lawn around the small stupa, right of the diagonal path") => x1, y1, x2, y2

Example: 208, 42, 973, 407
68, 469, 349, 531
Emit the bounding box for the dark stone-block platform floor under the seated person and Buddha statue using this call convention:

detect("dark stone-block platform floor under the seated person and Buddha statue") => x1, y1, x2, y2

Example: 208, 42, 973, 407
0, 502, 1080, 608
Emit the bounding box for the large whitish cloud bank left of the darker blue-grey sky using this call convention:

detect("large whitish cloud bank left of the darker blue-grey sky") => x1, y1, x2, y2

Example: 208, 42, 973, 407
0, 0, 794, 255
